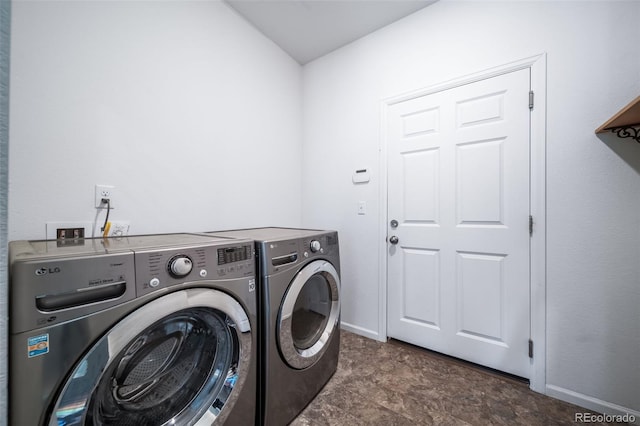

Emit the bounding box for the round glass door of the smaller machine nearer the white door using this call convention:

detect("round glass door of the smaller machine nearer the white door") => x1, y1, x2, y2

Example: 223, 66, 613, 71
277, 260, 340, 369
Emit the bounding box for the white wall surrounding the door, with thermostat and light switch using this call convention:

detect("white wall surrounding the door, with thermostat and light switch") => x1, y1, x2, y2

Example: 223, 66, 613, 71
303, 1, 640, 421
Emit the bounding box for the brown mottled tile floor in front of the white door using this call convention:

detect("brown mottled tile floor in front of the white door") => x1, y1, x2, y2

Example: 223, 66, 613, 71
291, 331, 624, 426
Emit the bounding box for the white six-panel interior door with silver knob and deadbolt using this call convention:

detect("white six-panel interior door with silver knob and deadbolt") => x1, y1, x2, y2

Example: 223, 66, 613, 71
387, 69, 530, 378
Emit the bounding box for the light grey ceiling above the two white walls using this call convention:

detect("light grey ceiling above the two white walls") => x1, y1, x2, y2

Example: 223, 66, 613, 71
225, 0, 437, 65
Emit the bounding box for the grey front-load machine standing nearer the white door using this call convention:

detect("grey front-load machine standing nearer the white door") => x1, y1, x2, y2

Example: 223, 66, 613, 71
212, 228, 340, 426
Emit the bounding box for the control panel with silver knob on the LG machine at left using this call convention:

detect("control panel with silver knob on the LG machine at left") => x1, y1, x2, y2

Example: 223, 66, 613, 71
135, 243, 255, 296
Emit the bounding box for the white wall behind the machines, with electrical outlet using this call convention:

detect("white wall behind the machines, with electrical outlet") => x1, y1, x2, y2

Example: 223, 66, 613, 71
9, 1, 301, 240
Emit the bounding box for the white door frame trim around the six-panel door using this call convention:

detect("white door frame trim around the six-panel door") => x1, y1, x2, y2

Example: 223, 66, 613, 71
378, 53, 547, 393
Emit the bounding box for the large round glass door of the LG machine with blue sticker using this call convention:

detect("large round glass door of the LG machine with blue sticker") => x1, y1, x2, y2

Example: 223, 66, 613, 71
49, 289, 251, 426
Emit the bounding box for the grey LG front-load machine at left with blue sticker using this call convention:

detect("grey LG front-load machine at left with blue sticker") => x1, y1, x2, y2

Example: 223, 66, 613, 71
9, 234, 258, 426
